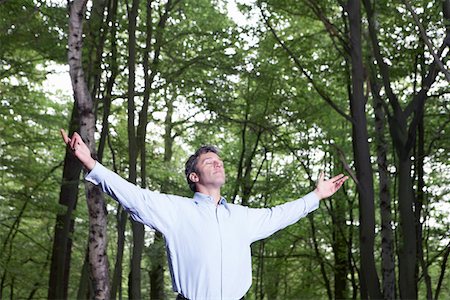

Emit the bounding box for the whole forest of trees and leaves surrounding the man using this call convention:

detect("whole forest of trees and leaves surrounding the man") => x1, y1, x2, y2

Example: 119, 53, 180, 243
0, 0, 450, 300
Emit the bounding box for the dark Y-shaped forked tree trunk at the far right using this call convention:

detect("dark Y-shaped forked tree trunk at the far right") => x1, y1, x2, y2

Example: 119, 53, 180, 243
364, 0, 450, 299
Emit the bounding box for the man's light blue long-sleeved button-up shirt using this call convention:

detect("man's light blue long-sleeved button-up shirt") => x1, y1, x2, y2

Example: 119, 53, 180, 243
86, 162, 319, 300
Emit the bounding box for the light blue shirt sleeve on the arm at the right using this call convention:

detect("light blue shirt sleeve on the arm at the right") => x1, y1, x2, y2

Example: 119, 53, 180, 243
248, 192, 320, 243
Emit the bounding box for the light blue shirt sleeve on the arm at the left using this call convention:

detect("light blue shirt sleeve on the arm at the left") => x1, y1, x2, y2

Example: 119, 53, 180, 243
85, 162, 177, 234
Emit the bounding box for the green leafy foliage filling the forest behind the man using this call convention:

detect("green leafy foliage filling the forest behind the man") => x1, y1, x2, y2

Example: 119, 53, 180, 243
0, 0, 450, 299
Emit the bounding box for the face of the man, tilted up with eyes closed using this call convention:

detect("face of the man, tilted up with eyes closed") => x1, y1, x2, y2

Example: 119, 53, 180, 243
192, 152, 225, 188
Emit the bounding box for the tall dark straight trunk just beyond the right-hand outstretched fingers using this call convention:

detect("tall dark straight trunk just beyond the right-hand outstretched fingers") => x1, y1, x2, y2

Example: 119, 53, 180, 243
347, 0, 382, 299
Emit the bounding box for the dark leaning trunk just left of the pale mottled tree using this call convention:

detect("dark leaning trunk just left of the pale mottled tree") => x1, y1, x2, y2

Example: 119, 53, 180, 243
47, 103, 81, 299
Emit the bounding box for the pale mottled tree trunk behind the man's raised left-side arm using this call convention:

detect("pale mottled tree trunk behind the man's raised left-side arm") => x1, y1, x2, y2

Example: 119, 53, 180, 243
68, 0, 110, 299
